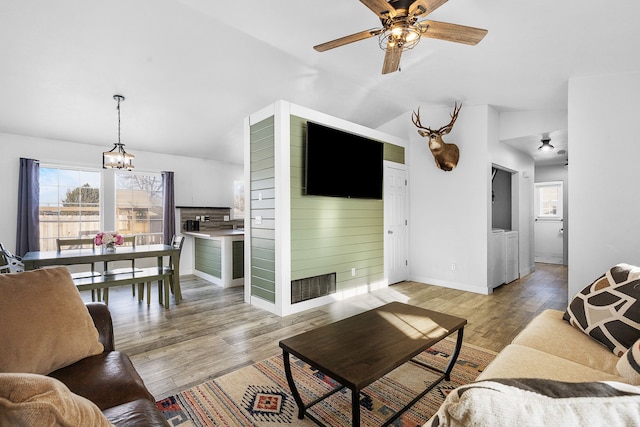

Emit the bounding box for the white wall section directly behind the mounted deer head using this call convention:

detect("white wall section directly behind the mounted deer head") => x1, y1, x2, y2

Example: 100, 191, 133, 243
379, 106, 497, 293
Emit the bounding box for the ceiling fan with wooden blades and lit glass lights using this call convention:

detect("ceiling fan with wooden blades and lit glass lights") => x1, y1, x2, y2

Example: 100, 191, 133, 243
313, 0, 487, 74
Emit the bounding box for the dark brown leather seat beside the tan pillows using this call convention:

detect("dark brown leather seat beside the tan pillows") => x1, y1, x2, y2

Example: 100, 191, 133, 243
49, 303, 169, 426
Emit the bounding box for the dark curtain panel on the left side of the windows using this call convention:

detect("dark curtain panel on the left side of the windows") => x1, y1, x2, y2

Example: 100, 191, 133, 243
16, 157, 40, 256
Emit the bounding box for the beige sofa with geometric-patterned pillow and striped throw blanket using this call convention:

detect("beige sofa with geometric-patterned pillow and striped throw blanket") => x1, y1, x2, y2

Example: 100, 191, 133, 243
425, 264, 640, 427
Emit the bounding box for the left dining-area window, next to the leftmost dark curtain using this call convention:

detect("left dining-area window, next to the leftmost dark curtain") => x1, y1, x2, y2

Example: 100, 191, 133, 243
39, 165, 100, 251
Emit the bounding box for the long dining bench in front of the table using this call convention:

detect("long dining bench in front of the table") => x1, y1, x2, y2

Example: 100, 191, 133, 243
73, 267, 173, 308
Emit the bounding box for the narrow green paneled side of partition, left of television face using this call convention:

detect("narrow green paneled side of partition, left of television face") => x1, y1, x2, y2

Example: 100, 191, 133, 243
249, 117, 276, 304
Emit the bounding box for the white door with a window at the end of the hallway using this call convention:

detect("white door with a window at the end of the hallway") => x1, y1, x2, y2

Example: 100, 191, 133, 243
533, 181, 564, 264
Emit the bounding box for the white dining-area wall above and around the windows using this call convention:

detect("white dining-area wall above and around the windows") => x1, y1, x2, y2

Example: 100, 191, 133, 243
0, 133, 243, 273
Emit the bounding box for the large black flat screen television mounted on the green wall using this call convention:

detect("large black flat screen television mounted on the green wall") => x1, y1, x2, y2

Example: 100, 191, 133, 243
304, 122, 384, 199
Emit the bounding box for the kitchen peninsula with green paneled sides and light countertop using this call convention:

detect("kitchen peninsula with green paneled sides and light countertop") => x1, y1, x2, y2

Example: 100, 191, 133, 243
182, 229, 244, 288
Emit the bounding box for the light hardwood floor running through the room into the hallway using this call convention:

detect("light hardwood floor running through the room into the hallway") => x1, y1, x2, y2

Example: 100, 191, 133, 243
83, 264, 567, 400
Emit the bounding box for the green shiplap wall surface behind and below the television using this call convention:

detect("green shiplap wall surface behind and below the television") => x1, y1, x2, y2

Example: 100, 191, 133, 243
290, 116, 404, 291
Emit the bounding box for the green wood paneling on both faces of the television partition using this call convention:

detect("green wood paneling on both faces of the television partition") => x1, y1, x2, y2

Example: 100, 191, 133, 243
247, 110, 405, 303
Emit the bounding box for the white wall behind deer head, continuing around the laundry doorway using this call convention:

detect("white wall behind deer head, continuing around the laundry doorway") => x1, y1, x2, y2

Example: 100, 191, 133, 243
378, 106, 540, 293
